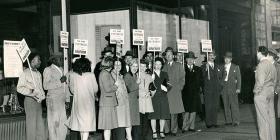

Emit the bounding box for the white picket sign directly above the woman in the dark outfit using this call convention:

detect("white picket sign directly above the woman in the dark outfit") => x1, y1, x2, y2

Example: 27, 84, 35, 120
147, 37, 162, 52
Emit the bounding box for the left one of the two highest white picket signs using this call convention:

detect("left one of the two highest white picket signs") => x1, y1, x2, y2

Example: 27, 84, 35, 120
110, 29, 124, 44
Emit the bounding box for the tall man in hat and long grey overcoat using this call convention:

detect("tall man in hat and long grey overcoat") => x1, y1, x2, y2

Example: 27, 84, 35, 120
163, 47, 185, 136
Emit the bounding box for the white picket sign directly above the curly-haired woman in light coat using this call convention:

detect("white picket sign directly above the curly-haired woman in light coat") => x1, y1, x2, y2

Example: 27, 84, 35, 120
74, 39, 88, 55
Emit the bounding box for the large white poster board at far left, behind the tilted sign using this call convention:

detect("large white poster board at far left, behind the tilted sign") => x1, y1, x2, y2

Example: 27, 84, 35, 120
3, 40, 23, 78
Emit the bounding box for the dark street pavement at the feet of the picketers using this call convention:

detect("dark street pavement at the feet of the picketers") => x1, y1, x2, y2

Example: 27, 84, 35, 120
90, 104, 259, 140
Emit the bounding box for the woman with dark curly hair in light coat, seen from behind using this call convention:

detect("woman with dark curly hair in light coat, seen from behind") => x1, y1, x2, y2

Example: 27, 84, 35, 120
66, 58, 98, 140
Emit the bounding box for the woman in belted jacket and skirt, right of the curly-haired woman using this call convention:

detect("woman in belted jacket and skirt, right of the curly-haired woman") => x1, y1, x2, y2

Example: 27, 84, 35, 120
98, 57, 118, 140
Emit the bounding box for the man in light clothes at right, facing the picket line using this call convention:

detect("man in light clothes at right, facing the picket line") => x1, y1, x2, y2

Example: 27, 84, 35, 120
253, 46, 277, 140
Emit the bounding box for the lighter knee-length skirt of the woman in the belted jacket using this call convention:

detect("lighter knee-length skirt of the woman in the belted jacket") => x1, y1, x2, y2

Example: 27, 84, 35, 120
98, 106, 118, 130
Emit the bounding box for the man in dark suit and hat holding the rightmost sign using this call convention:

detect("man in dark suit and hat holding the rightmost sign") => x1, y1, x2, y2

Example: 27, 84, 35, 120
202, 51, 222, 128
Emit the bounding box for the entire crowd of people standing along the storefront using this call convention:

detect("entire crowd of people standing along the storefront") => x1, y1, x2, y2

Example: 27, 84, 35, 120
14, 43, 280, 140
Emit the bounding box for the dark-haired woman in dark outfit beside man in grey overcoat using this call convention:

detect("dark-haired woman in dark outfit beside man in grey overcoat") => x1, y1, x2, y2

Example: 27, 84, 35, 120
149, 57, 171, 139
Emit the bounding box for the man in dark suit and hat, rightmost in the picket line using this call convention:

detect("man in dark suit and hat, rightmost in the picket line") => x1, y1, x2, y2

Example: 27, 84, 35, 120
221, 52, 241, 126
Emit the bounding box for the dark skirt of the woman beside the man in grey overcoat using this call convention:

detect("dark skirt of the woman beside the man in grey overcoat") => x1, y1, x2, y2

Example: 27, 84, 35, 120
148, 91, 170, 120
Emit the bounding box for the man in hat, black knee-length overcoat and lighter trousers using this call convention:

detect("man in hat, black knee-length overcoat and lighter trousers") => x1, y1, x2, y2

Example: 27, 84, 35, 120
182, 51, 203, 133
